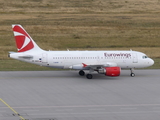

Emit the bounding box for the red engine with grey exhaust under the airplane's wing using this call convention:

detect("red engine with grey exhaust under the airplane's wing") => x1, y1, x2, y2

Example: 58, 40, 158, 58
98, 67, 121, 77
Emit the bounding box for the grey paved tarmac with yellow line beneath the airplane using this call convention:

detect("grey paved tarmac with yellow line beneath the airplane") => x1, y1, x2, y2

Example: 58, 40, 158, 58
0, 69, 160, 120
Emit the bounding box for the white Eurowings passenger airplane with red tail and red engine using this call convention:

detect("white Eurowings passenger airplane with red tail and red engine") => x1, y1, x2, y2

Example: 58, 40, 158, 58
9, 24, 154, 79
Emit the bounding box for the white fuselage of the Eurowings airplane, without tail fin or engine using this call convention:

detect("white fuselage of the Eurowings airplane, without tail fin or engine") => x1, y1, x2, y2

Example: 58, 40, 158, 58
10, 50, 154, 70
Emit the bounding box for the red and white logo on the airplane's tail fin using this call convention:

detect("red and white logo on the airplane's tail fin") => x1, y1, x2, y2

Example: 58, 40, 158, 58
13, 25, 34, 52
